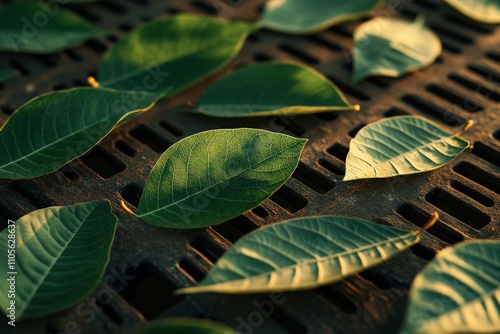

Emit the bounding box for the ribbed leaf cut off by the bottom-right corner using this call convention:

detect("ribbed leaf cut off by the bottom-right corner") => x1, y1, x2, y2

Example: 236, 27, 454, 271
400, 241, 500, 334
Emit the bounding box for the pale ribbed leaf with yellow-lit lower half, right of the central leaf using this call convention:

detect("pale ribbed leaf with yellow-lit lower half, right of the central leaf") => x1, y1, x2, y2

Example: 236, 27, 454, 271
344, 116, 470, 181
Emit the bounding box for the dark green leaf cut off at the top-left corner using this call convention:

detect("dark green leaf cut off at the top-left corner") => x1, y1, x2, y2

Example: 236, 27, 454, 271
0, 1, 104, 54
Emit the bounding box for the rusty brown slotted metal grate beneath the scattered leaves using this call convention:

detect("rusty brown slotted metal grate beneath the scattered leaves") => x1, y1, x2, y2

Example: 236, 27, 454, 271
0, 0, 500, 333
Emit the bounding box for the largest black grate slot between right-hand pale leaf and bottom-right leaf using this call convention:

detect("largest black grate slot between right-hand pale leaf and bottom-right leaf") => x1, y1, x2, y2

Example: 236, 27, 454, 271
425, 188, 491, 230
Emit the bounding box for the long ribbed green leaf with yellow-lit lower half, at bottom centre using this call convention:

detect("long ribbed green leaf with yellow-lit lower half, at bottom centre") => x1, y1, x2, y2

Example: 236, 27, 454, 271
176, 216, 420, 294
